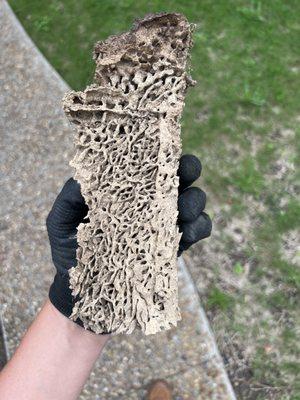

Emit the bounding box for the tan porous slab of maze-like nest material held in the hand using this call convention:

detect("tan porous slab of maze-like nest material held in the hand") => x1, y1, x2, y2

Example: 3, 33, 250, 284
63, 13, 195, 334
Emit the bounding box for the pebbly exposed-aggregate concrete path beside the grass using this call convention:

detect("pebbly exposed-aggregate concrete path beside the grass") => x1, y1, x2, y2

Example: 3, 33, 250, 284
0, 0, 234, 400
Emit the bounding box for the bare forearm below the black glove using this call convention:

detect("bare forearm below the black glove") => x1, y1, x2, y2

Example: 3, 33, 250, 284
0, 300, 109, 400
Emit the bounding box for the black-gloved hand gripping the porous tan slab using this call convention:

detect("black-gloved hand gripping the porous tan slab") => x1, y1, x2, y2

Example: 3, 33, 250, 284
46, 155, 211, 326
